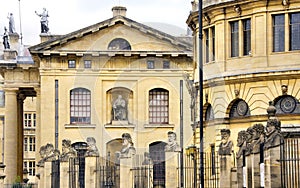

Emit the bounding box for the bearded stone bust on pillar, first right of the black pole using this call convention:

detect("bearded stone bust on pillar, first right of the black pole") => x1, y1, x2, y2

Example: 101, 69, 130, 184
218, 129, 233, 155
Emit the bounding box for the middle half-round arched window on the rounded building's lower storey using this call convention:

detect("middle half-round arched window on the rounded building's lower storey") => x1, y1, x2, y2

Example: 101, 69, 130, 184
229, 99, 250, 118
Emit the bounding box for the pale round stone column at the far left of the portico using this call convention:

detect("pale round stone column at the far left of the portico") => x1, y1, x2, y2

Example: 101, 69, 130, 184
4, 88, 18, 183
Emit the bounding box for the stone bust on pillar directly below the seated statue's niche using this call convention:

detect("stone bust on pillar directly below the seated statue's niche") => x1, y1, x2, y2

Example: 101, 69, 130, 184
120, 133, 136, 158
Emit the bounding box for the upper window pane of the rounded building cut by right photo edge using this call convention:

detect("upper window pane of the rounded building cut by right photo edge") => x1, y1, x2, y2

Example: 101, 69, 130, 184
290, 13, 300, 50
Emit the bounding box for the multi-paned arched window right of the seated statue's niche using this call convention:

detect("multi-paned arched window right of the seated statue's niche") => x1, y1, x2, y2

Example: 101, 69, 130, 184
149, 88, 169, 124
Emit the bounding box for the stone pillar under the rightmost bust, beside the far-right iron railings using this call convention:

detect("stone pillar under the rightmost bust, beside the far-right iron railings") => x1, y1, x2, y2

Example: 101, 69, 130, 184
265, 146, 281, 188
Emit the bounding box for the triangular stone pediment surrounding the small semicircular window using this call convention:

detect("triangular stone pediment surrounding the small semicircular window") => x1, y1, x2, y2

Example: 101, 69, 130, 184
29, 16, 192, 55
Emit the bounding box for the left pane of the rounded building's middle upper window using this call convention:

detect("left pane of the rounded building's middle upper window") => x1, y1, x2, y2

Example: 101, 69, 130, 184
230, 21, 239, 57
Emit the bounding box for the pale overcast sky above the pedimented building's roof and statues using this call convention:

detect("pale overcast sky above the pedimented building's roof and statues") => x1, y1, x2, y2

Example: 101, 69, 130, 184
0, 0, 191, 45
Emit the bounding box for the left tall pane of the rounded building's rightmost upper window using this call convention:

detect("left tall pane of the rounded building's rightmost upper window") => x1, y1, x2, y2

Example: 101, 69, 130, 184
273, 14, 284, 52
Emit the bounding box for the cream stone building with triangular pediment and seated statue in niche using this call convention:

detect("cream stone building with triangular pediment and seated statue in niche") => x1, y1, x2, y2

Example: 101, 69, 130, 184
1, 7, 193, 186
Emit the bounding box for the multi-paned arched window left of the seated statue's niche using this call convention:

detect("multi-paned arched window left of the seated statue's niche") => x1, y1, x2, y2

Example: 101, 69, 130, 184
70, 88, 91, 124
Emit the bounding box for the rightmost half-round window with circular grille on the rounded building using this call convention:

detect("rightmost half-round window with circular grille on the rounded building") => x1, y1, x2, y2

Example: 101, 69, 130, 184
274, 95, 300, 114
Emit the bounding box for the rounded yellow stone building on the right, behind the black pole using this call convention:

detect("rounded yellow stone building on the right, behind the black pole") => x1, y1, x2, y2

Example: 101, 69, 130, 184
187, 0, 300, 186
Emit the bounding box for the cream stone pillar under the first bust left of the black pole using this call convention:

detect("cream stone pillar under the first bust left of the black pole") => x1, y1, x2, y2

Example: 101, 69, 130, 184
165, 152, 179, 188
